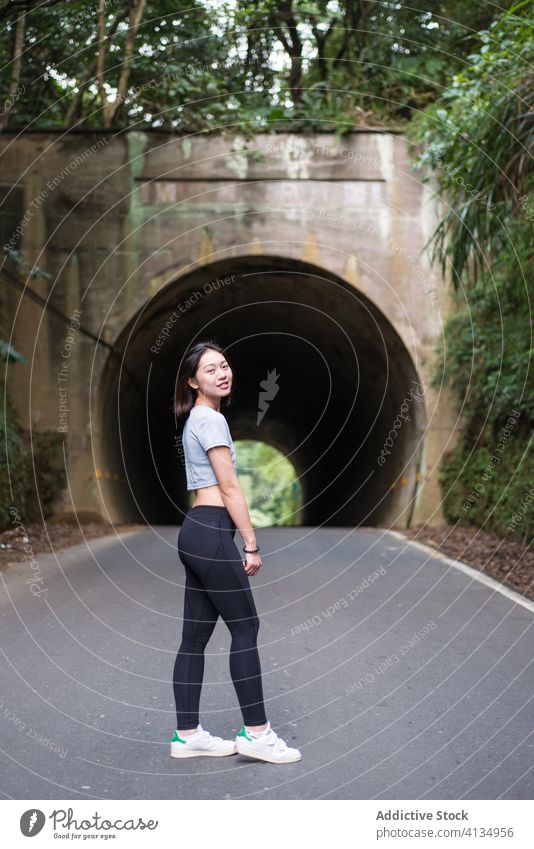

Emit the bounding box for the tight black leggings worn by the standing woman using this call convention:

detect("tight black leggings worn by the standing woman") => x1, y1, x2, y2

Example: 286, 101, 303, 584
173, 504, 267, 730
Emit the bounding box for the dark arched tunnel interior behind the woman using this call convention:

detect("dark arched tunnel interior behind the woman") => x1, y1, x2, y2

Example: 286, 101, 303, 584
98, 256, 426, 527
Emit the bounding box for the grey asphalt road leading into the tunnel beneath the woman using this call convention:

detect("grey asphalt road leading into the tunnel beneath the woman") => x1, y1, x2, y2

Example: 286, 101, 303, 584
0, 526, 534, 800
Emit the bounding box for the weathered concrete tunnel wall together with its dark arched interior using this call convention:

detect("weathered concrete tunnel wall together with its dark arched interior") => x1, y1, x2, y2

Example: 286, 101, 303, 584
0, 132, 457, 528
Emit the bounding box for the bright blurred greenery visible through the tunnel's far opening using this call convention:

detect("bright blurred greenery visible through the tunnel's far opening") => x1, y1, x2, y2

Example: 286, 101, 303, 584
235, 440, 301, 527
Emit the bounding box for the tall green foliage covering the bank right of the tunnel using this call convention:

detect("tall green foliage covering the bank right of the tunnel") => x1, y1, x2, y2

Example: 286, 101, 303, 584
409, 3, 534, 542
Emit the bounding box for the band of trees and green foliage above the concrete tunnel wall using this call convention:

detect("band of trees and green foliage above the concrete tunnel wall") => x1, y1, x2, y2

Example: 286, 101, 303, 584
0, 0, 520, 133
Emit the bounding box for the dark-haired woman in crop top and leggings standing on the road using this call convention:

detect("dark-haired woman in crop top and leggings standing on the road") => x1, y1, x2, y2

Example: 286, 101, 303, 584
171, 342, 301, 763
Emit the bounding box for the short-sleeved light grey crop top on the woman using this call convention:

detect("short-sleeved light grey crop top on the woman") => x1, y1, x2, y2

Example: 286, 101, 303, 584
182, 404, 237, 489
